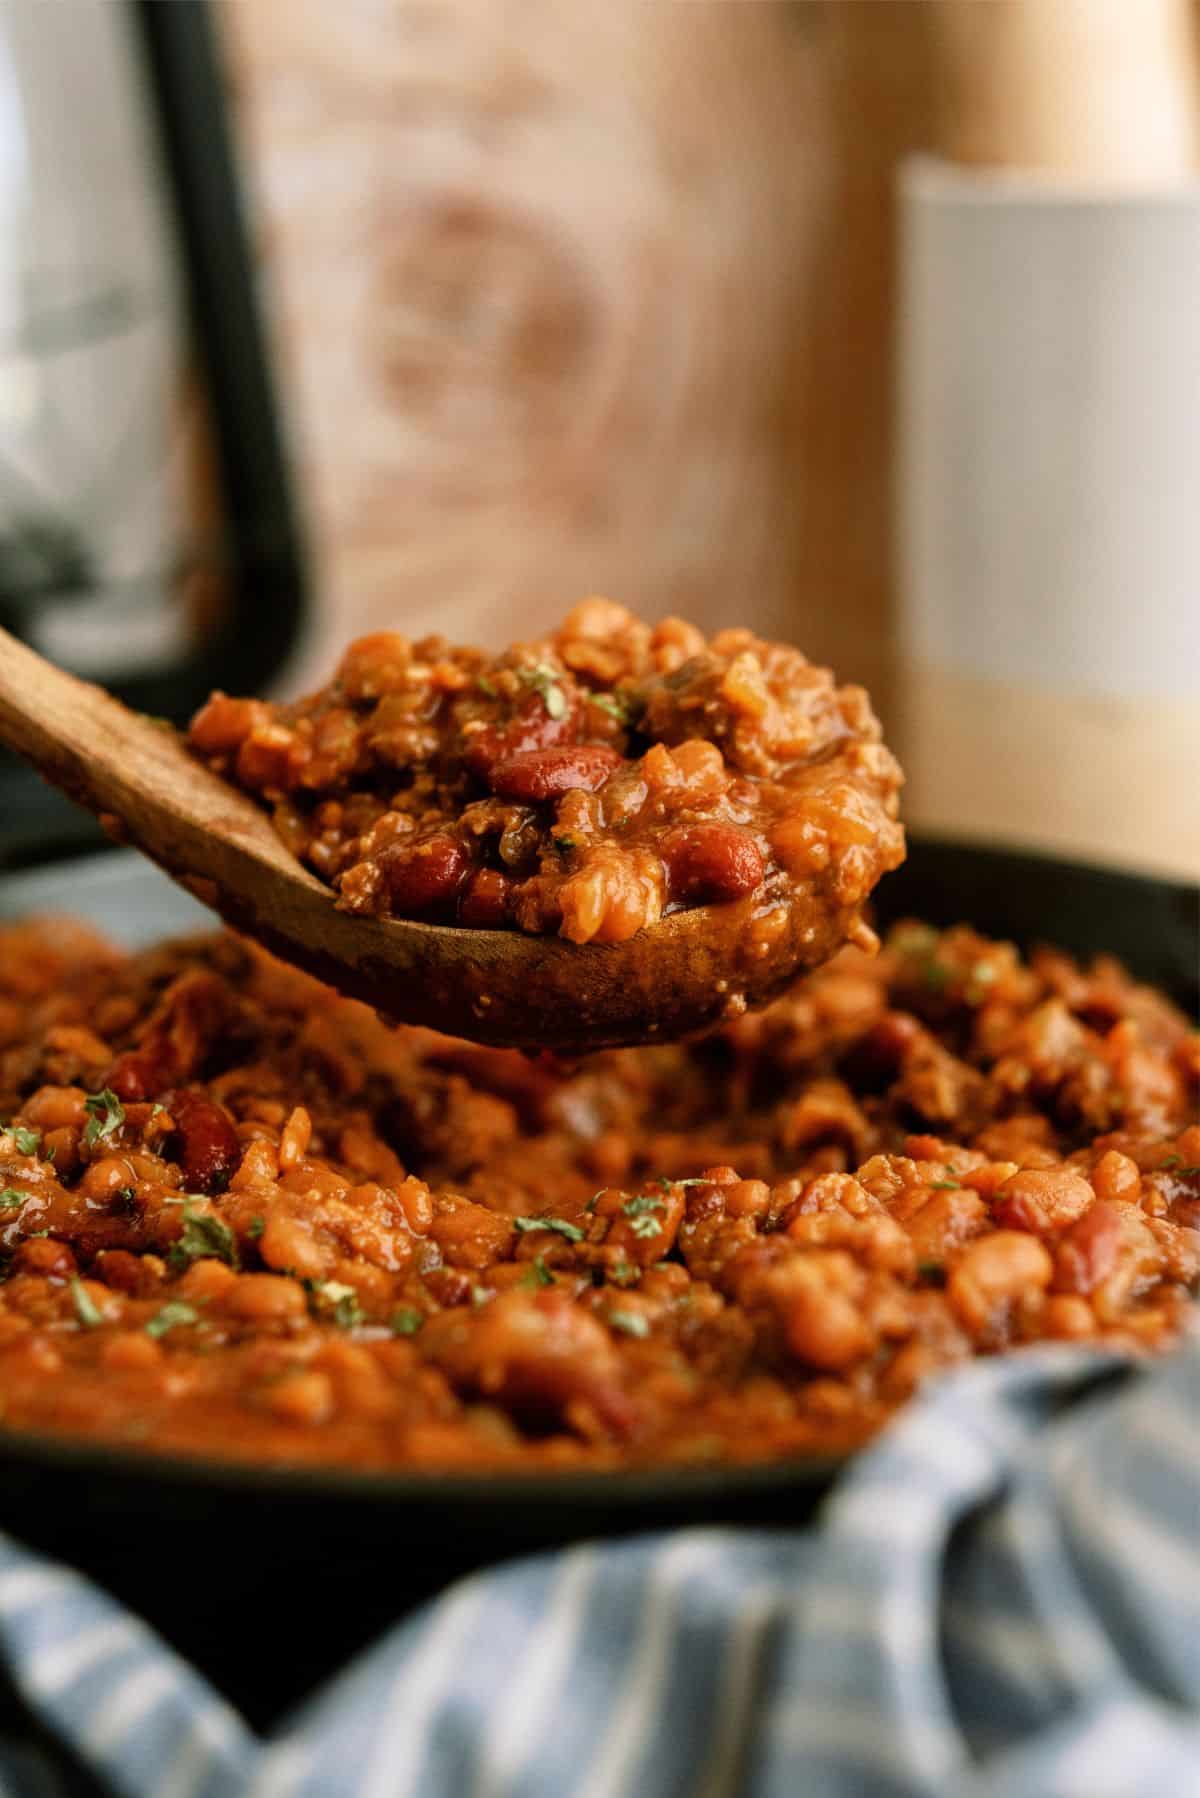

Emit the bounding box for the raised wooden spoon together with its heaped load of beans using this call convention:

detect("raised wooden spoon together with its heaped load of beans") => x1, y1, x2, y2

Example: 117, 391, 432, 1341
0, 599, 903, 1052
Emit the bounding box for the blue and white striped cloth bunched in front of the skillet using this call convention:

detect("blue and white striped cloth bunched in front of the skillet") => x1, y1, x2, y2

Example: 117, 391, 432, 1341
0, 1341, 1200, 1798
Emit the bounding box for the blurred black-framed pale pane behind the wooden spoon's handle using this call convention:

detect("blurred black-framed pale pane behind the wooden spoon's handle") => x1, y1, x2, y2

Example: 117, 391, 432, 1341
0, 0, 304, 867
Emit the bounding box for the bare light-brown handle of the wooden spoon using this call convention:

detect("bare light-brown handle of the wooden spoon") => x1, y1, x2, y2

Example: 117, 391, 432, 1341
0, 629, 297, 885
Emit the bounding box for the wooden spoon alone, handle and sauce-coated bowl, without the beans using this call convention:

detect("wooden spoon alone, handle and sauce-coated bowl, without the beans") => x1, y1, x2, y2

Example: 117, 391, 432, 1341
0, 631, 862, 1052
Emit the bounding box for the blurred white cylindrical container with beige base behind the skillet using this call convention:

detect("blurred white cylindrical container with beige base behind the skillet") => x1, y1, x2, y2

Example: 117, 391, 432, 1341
896, 158, 1200, 879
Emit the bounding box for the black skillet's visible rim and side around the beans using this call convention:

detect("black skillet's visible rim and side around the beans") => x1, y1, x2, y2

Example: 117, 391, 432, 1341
0, 841, 1200, 1724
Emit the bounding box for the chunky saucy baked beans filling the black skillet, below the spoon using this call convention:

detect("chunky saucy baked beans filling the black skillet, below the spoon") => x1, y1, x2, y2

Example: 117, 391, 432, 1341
0, 922, 1200, 1471
